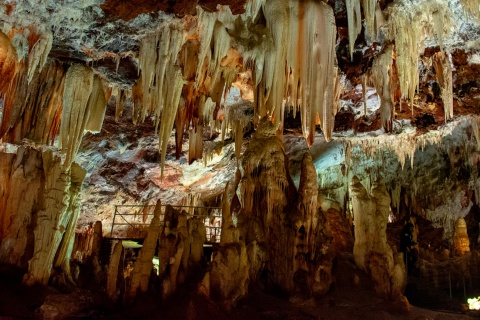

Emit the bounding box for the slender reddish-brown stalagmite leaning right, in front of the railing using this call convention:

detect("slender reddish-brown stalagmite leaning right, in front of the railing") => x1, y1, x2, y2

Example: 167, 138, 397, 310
127, 200, 162, 301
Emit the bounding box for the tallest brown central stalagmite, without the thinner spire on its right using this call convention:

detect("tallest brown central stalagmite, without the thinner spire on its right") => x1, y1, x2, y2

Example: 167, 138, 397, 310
238, 118, 296, 292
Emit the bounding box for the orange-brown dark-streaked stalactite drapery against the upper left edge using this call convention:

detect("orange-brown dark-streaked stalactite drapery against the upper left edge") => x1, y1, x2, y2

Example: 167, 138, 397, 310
0, 31, 65, 144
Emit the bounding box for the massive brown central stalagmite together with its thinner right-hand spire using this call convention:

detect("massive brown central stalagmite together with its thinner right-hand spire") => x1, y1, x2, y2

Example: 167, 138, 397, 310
234, 121, 341, 297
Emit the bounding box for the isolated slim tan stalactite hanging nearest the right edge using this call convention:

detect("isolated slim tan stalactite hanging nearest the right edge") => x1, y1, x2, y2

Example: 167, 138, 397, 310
432, 52, 453, 122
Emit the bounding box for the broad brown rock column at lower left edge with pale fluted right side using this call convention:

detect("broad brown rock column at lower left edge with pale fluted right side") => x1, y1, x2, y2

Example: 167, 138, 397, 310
0, 147, 85, 284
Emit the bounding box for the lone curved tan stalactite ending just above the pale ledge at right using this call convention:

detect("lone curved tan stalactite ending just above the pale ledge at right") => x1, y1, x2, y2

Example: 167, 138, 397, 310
372, 45, 395, 132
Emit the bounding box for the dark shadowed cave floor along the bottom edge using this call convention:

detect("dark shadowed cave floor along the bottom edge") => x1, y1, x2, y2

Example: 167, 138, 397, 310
0, 269, 478, 320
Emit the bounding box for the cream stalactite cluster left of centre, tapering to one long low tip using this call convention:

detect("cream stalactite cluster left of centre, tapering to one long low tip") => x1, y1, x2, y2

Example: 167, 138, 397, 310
139, 22, 186, 174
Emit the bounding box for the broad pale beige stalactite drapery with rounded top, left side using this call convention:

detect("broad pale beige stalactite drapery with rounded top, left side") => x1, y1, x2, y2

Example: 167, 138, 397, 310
59, 65, 106, 168
